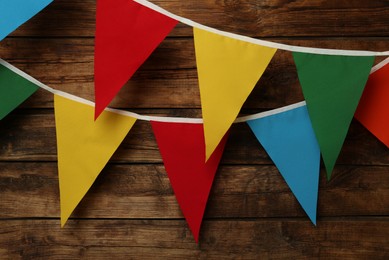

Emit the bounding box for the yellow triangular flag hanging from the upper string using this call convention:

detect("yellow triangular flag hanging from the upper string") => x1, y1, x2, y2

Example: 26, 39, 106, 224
194, 28, 277, 159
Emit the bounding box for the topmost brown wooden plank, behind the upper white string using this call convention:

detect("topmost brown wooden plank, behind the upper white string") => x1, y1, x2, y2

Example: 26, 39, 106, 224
7, 0, 389, 37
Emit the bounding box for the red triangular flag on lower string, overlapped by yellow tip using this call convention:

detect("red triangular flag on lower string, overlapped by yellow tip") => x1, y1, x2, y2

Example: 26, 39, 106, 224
151, 122, 227, 242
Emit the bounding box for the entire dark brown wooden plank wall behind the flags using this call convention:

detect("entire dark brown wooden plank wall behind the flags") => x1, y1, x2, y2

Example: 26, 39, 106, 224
0, 0, 389, 259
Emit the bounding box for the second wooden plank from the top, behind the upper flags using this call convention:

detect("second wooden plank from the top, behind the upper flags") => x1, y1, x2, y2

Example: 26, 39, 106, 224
0, 38, 389, 109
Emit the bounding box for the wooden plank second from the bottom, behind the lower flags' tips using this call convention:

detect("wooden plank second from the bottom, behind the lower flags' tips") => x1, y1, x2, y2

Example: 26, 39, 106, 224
0, 162, 389, 219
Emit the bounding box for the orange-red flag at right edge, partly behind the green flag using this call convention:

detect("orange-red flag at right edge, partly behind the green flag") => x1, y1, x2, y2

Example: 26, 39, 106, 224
355, 59, 389, 148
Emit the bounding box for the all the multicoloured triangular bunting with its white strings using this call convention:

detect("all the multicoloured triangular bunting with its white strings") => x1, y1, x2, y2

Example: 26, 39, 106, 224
0, 0, 389, 242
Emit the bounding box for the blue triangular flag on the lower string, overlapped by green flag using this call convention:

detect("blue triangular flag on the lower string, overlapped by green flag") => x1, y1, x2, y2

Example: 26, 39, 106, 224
247, 106, 320, 225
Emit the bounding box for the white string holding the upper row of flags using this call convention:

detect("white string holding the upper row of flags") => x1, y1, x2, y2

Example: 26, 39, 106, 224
134, 0, 389, 56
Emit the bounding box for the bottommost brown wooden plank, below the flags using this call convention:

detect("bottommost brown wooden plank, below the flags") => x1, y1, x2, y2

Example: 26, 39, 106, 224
0, 218, 389, 259
